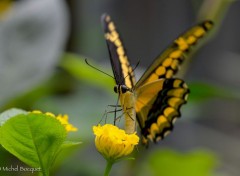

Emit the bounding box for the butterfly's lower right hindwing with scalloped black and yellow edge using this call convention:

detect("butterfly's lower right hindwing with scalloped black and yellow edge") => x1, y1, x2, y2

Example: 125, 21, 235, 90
135, 78, 189, 144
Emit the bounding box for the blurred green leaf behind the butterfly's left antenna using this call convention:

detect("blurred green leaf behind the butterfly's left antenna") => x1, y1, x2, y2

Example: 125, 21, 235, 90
60, 53, 114, 92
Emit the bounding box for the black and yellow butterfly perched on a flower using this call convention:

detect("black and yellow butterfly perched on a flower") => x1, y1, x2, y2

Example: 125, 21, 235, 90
102, 14, 213, 144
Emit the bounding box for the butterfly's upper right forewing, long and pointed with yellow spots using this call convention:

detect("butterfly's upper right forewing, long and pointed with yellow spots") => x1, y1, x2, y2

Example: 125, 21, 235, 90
136, 20, 213, 87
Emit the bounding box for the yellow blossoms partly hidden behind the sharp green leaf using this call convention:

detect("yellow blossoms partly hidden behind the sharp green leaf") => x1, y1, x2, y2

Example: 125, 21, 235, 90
32, 110, 78, 132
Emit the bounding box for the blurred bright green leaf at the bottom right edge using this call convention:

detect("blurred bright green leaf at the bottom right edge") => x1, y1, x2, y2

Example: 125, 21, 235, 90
139, 150, 217, 176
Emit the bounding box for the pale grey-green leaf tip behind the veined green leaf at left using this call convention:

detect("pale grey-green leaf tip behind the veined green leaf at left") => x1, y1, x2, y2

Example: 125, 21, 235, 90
0, 108, 27, 126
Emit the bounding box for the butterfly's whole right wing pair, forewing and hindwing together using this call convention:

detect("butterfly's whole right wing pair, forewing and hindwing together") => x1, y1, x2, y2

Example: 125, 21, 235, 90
135, 21, 213, 144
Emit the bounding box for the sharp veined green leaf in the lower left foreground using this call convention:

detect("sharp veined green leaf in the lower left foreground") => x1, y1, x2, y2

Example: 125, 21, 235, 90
0, 113, 66, 175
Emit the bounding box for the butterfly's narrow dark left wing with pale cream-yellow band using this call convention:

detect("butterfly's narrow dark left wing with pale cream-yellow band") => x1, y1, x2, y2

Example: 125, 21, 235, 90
101, 14, 136, 88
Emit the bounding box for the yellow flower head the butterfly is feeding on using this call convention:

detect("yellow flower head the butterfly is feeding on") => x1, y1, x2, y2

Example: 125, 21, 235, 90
93, 124, 139, 161
